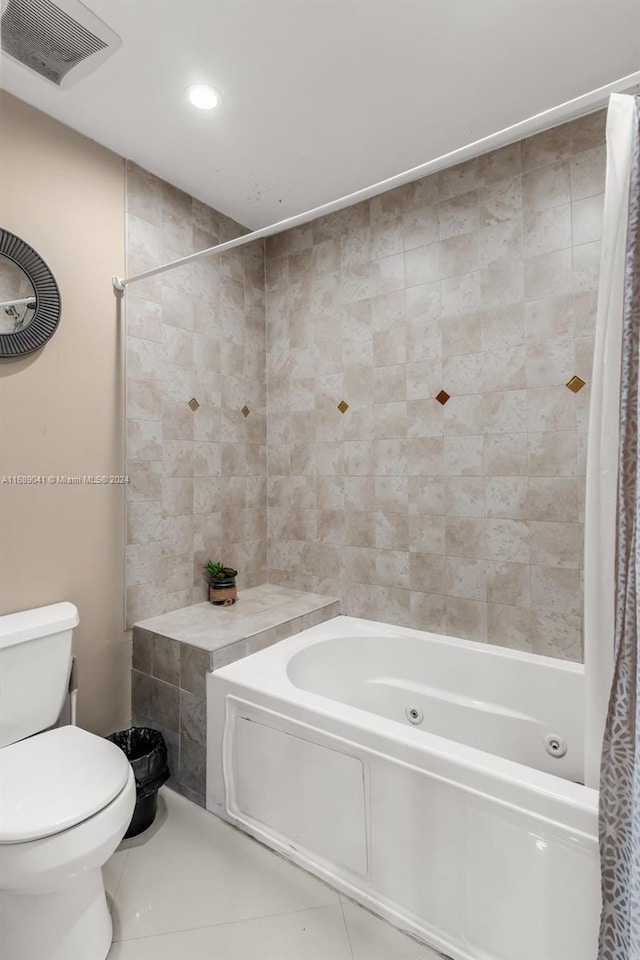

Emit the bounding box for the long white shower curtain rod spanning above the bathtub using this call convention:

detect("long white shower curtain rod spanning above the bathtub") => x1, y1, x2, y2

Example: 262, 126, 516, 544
111, 71, 640, 292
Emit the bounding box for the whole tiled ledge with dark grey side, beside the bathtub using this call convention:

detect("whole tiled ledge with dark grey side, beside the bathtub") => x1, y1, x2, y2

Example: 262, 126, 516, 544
131, 584, 340, 806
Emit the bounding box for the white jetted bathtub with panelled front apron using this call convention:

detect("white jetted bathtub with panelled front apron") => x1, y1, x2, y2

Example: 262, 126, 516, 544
207, 617, 600, 960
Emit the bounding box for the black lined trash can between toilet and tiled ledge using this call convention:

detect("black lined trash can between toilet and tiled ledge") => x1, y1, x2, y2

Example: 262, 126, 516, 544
107, 727, 170, 840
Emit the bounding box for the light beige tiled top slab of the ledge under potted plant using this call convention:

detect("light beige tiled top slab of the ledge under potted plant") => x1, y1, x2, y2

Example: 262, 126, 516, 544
134, 584, 340, 669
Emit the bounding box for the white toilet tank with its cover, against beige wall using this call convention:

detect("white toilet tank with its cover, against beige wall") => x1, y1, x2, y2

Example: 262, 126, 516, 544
0, 603, 79, 748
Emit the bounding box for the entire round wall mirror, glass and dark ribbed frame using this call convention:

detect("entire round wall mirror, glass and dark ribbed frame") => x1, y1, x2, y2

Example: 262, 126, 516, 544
0, 228, 62, 357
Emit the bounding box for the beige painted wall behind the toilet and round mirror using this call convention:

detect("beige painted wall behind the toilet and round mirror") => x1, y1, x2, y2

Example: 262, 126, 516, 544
0, 92, 130, 734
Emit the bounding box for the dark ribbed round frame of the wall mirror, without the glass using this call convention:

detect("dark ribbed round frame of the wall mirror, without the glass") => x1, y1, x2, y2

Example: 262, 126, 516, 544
0, 227, 62, 358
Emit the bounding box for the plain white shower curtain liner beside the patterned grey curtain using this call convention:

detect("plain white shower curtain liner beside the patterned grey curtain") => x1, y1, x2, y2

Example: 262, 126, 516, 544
584, 94, 635, 789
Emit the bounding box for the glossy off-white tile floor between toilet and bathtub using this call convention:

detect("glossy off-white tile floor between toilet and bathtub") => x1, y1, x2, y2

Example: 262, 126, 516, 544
104, 788, 440, 960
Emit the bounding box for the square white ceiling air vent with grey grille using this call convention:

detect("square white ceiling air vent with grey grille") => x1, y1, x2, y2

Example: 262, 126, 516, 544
0, 0, 121, 87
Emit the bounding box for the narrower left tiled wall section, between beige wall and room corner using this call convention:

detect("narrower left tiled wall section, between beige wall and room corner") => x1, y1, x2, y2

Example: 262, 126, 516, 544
126, 163, 267, 625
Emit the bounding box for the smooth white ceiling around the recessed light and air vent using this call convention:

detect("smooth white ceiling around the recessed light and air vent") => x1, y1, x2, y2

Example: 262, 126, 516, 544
1, 0, 640, 227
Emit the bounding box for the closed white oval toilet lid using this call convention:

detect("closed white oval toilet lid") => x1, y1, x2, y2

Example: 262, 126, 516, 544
0, 727, 131, 843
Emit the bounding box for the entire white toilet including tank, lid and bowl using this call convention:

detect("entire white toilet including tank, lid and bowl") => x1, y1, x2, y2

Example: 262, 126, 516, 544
0, 603, 136, 960
